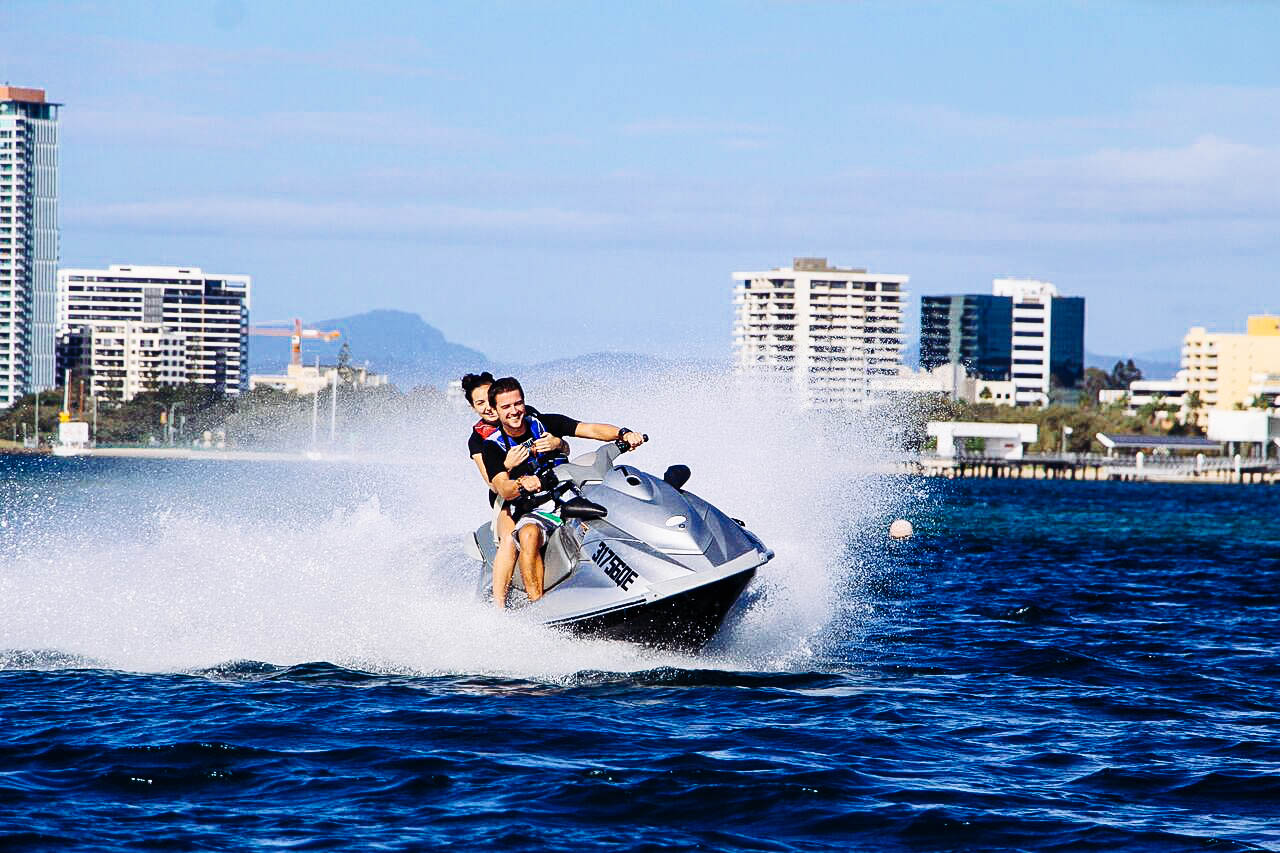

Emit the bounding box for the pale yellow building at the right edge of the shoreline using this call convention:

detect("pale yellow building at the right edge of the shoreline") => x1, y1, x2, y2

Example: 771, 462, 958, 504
1183, 314, 1280, 420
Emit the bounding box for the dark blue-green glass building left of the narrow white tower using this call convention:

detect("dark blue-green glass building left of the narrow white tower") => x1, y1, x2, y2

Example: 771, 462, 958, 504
920, 293, 1014, 382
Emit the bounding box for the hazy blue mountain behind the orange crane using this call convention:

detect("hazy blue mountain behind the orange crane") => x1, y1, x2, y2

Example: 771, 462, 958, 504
250, 310, 489, 388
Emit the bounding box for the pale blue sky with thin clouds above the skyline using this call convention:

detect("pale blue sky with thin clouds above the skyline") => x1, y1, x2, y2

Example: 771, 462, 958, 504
0, 0, 1280, 362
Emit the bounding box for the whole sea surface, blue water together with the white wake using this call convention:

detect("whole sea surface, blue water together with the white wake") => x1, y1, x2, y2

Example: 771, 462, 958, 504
0, 457, 1280, 850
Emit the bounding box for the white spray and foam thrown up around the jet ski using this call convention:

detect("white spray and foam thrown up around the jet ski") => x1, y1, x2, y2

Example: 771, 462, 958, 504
0, 374, 897, 680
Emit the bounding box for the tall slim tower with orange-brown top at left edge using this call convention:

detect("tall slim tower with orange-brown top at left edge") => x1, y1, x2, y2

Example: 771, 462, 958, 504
0, 86, 61, 407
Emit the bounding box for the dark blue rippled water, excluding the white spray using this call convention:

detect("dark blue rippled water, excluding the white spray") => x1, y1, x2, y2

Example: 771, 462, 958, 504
0, 473, 1280, 853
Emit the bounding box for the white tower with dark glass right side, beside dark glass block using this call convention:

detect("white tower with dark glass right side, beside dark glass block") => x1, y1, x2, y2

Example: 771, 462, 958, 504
991, 278, 1084, 406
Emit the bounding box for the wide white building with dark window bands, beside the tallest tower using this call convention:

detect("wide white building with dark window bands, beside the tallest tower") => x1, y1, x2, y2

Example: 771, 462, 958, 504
58, 264, 251, 394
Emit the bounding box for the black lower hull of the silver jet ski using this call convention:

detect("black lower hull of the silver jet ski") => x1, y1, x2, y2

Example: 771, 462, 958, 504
550, 567, 755, 652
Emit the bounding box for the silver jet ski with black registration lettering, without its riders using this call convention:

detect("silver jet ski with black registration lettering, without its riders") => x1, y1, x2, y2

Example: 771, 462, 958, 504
467, 435, 773, 651
